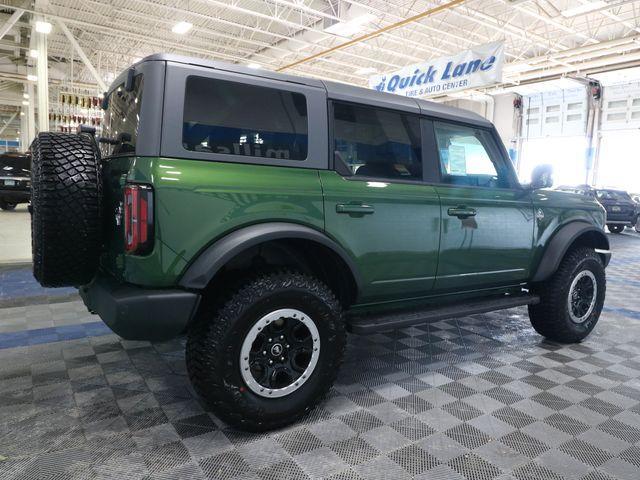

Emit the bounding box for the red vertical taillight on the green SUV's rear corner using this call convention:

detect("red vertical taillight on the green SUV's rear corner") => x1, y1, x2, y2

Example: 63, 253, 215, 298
124, 183, 153, 255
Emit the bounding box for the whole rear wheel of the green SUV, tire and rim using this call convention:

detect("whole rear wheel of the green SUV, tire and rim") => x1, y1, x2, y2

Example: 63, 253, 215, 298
186, 272, 346, 431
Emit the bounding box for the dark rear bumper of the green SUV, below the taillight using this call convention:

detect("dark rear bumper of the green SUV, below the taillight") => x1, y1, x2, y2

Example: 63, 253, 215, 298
80, 276, 200, 341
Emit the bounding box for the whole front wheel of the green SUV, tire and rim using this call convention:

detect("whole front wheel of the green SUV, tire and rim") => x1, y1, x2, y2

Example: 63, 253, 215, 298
529, 248, 606, 343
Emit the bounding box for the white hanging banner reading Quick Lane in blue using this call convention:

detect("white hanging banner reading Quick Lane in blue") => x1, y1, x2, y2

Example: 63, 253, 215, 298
369, 42, 504, 97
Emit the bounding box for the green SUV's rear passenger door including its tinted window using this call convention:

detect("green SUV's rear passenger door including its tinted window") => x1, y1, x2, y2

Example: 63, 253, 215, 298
320, 102, 440, 302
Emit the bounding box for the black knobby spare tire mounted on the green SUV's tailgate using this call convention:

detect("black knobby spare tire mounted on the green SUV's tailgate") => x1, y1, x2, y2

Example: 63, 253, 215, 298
31, 132, 102, 287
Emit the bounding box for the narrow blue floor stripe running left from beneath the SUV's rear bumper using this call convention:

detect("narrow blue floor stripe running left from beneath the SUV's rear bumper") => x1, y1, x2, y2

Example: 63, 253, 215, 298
0, 322, 113, 350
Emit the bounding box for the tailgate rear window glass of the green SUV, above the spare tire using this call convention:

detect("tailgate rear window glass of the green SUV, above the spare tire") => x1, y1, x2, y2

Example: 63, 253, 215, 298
100, 75, 144, 157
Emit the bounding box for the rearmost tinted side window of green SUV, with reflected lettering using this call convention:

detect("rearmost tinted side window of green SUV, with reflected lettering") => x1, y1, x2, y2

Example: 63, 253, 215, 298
182, 76, 308, 160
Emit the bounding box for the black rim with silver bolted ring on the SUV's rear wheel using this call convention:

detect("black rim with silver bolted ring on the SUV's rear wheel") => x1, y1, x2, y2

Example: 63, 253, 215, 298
240, 308, 320, 398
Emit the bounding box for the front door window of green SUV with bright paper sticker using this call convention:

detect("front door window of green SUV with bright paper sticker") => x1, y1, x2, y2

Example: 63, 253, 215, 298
434, 122, 509, 187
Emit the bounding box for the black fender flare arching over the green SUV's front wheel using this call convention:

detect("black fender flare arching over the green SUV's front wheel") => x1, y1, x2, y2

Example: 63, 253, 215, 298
532, 221, 611, 282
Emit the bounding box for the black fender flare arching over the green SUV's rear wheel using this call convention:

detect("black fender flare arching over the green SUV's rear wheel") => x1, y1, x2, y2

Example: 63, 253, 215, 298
180, 222, 362, 292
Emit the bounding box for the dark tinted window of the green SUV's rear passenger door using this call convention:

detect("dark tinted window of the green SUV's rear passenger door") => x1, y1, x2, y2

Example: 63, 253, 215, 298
333, 103, 422, 180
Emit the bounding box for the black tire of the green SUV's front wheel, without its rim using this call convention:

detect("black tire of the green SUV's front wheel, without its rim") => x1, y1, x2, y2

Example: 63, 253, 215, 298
529, 247, 606, 343
